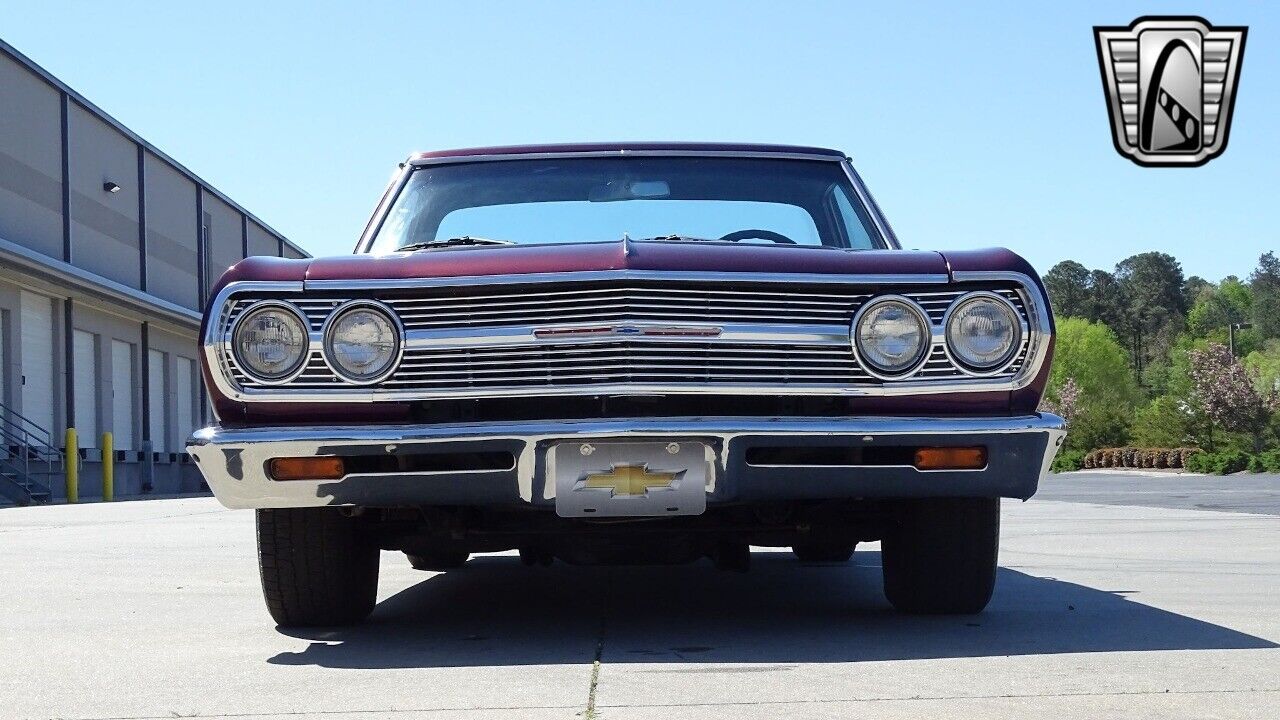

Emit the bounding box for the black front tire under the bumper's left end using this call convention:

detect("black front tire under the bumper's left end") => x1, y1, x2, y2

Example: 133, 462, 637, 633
257, 507, 380, 626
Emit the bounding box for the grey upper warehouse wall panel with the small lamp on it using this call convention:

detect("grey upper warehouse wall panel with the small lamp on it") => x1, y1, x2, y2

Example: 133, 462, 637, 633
68, 104, 141, 288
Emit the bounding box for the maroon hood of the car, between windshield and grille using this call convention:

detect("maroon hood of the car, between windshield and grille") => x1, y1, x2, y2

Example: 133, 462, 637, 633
294, 241, 947, 282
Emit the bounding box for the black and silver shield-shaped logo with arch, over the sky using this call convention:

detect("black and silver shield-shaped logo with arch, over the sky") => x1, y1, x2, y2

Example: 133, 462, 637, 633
1093, 17, 1248, 167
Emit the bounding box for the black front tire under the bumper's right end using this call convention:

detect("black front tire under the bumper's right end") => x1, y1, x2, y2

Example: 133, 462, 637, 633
881, 497, 1000, 615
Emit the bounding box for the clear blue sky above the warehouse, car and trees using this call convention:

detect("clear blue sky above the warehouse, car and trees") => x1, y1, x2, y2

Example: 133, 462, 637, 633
0, 1, 1280, 279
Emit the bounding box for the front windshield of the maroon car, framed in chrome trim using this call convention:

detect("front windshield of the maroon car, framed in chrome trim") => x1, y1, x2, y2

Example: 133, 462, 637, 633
367, 156, 884, 254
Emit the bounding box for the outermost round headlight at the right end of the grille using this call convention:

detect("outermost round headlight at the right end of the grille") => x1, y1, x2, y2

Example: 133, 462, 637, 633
946, 292, 1023, 373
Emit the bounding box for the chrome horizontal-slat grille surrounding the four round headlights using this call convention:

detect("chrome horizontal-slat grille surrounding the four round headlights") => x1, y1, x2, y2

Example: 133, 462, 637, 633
221, 281, 1029, 397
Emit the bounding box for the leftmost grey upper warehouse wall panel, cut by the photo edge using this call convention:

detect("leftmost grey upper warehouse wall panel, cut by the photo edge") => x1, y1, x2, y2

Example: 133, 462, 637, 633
0, 55, 63, 259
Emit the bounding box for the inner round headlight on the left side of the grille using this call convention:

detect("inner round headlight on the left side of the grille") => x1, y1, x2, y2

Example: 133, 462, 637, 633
324, 300, 401, 384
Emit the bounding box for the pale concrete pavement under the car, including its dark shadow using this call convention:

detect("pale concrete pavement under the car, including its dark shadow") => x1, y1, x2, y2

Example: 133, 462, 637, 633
0, 484, 1280, 720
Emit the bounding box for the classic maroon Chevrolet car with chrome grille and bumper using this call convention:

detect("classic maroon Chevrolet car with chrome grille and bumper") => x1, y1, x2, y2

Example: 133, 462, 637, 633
189, 143, 1064, 625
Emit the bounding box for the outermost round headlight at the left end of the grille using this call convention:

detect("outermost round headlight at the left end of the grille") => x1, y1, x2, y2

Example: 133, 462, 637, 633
232, 302, 310, 382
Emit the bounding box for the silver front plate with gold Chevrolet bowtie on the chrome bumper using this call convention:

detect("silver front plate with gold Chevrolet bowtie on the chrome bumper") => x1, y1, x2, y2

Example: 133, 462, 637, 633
548, 442, 707, 518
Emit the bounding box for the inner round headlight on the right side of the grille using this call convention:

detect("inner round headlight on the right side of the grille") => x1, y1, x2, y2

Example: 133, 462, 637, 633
854, 296, 929, 377
